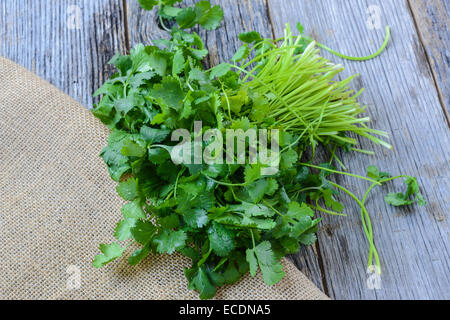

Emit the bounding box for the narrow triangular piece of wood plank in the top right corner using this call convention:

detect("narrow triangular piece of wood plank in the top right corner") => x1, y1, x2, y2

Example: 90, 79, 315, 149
408, 0, 450, 114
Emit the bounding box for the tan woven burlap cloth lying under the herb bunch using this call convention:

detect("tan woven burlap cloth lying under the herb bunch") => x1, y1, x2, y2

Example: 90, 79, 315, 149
0, 58, 327, 300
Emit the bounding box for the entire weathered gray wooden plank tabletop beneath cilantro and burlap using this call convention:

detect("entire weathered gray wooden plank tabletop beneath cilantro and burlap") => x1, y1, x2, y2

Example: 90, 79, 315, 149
0, 0, 450, 299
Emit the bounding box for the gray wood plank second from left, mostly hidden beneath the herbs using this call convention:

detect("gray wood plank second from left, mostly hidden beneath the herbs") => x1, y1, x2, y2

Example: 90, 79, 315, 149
127, 0, 324, 290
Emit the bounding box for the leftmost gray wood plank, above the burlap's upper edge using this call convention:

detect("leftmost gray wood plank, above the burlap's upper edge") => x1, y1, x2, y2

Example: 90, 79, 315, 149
0, 0, 125, 108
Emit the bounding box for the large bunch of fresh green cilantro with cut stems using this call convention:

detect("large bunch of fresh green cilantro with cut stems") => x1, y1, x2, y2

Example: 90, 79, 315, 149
93, 0, 426, 299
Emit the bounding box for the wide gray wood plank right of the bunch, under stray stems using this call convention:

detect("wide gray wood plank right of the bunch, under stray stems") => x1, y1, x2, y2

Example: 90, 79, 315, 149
268, 0, 450, 299
